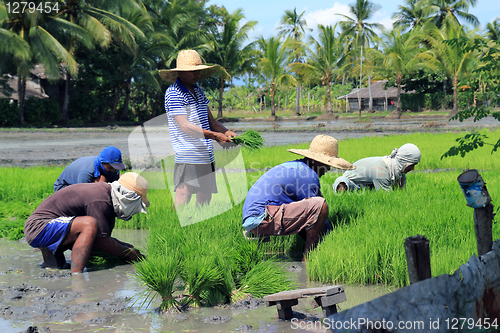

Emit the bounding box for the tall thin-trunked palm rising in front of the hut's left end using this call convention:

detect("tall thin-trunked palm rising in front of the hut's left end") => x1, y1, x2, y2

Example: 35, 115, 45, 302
337, 0, 382, 118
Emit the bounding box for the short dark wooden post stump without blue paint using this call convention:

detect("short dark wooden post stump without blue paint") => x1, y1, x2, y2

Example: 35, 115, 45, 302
404, 235, 431, 284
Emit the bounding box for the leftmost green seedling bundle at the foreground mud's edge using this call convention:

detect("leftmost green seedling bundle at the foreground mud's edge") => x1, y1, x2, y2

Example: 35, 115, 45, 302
134, 251, 181, 311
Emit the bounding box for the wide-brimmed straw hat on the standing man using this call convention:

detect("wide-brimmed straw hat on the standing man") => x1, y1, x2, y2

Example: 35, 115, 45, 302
159, 50, 220, 82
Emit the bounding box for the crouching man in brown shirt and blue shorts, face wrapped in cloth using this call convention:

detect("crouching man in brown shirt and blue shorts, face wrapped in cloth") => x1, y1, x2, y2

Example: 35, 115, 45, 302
24, 172, 149, 273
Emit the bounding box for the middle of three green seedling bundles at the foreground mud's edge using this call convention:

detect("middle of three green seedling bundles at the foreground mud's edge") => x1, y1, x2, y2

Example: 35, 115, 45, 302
180, 253, 221, 307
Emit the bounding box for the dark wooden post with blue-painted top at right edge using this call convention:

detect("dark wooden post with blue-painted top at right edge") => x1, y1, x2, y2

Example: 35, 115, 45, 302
457, 169, 495, 256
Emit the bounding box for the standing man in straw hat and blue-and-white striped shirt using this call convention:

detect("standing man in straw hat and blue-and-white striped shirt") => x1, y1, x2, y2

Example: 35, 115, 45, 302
160, 50, 236, 207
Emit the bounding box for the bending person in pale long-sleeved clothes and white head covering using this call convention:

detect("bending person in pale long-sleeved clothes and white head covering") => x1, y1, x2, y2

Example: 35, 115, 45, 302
332, 143, 421, 192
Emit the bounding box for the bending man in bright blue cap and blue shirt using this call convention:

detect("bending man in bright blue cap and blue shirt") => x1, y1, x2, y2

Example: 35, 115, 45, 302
54, 146, 125, 192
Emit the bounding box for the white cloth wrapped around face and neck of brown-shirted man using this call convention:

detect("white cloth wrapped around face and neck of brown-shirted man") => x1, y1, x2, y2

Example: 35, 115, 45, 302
111, 181, 147, 221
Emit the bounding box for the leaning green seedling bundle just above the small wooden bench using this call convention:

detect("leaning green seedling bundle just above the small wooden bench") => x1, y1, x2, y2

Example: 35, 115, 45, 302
231, 260, 296, 300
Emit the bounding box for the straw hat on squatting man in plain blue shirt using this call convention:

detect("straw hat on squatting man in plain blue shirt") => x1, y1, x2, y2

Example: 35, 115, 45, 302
287, 135, 356, 170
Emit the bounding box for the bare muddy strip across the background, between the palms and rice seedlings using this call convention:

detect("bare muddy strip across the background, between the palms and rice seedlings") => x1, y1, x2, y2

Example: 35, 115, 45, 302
0, 116, 500, 167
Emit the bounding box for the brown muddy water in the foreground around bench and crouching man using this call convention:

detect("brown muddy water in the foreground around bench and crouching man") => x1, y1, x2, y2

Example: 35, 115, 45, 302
0, 230, 389, 333
